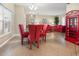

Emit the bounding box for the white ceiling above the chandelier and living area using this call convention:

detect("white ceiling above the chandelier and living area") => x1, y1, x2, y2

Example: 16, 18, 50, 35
17, 3, 66, 15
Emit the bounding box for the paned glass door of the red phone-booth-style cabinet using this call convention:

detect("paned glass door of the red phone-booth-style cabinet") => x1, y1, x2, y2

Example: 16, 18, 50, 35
69, 17, 77, 38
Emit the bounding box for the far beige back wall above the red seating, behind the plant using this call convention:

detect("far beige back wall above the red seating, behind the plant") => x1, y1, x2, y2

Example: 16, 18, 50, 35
31, 15, 62, 25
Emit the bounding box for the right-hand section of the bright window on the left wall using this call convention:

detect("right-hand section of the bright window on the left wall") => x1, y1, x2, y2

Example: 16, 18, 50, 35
4, 9, 11, 33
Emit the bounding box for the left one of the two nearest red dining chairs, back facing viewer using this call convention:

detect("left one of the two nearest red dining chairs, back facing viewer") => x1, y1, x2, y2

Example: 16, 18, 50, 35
28, 25, 36, 49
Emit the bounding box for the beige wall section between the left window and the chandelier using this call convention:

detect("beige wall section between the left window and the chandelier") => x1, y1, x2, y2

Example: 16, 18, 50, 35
15, 5, 26, 34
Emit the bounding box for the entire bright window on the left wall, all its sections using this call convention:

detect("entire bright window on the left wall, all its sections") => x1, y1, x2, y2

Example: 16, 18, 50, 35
0, 5, 12, 35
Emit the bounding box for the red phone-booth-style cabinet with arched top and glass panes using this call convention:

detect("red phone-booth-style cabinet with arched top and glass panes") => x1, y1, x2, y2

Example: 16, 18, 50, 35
65, 10, 79, 44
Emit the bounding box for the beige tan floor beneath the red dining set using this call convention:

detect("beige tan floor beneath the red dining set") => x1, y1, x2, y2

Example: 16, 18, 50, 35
0, 32, 79, 56
